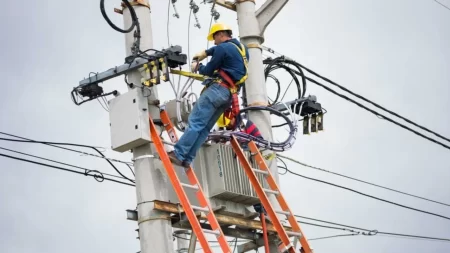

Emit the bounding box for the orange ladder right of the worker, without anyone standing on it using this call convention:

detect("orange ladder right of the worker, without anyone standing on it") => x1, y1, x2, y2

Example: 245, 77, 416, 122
231, 136, 312, 253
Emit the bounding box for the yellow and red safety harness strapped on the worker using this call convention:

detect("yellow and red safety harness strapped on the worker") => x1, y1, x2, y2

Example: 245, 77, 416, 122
217, 42, 248, 130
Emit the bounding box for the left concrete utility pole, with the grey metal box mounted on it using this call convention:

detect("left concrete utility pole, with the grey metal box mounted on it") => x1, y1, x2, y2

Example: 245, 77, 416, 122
123, 0, 174, 253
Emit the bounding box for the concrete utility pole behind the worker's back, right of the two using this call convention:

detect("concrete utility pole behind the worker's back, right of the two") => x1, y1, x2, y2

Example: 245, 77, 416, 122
236, 0, 288, 253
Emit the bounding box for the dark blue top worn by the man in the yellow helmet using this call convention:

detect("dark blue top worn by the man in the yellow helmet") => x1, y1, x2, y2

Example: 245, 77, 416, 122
198, 38, 250, 82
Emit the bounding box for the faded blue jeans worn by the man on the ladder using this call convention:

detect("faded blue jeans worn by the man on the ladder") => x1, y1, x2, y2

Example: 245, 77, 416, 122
174, 83, 231, 163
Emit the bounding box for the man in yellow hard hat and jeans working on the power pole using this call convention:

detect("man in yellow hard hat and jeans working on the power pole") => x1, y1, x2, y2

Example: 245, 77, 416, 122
168, 23, 249, 168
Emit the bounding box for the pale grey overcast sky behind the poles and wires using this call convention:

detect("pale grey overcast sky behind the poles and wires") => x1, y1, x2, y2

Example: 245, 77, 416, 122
0, 0, 450, 253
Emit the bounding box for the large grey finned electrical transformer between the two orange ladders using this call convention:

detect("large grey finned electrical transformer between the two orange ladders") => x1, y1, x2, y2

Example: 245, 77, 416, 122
169, 141, 267, 216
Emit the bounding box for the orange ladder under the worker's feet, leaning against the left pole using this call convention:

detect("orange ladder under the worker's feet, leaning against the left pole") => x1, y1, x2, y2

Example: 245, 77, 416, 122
149, 110, 231, 253
